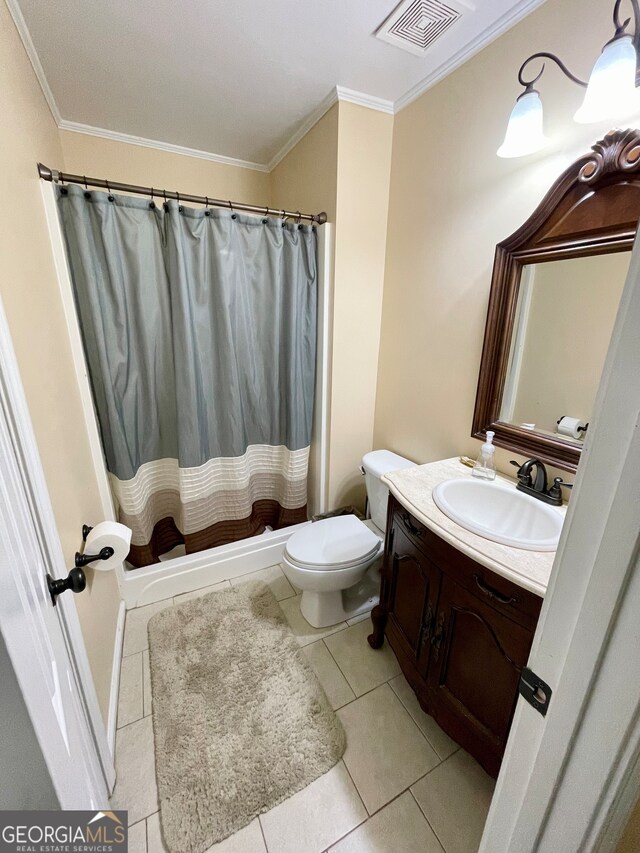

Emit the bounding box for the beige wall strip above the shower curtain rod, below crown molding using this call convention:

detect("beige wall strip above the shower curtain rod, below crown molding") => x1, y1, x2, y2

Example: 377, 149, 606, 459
58, 130, 271, 205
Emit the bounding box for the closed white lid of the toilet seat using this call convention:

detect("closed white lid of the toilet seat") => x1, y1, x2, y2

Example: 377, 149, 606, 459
285, 515, 381, 569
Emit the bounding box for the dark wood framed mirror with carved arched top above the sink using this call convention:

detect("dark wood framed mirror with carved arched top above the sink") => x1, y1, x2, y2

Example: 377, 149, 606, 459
471, 130, 640, 471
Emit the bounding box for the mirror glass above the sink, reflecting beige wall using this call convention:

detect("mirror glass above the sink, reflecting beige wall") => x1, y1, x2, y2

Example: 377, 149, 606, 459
500, 252, 631, 444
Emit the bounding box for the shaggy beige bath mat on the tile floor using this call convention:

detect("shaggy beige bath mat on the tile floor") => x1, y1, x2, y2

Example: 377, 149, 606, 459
149, 582, 345, 853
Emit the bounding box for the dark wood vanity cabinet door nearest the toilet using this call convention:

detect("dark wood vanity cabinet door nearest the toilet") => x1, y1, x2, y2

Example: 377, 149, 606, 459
387, 526, 440, 676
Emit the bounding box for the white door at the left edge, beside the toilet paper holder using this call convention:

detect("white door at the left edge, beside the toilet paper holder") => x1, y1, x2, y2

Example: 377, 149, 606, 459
0, 306, 108, 809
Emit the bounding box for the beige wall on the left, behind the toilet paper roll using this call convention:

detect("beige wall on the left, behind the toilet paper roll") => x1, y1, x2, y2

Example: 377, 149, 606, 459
0, 3, 120, 720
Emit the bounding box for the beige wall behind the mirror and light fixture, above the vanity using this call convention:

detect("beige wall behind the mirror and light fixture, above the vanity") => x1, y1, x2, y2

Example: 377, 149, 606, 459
374, 0, 632, 480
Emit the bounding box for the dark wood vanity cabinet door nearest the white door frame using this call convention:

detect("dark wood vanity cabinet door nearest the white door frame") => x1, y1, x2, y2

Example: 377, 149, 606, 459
427, 575, 533, 776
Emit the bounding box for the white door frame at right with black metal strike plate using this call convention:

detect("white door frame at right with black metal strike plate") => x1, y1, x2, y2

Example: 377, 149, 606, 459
480, 228, 640, 853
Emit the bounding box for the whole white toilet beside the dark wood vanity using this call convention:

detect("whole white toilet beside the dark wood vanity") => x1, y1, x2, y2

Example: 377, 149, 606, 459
282, 450, 415, 628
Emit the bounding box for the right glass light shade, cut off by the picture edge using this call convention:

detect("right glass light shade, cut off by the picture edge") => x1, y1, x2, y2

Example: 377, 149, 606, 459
574, 36, 640, 124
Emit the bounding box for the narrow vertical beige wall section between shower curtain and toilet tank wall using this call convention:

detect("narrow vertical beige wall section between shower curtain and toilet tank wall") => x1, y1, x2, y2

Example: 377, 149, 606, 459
329, 102, 393, 506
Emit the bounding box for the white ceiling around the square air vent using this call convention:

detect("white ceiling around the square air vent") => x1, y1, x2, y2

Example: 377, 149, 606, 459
8, 0, 544, 169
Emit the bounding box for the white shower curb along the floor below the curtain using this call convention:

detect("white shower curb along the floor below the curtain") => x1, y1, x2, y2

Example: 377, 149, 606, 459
120, 521, 310, 610
